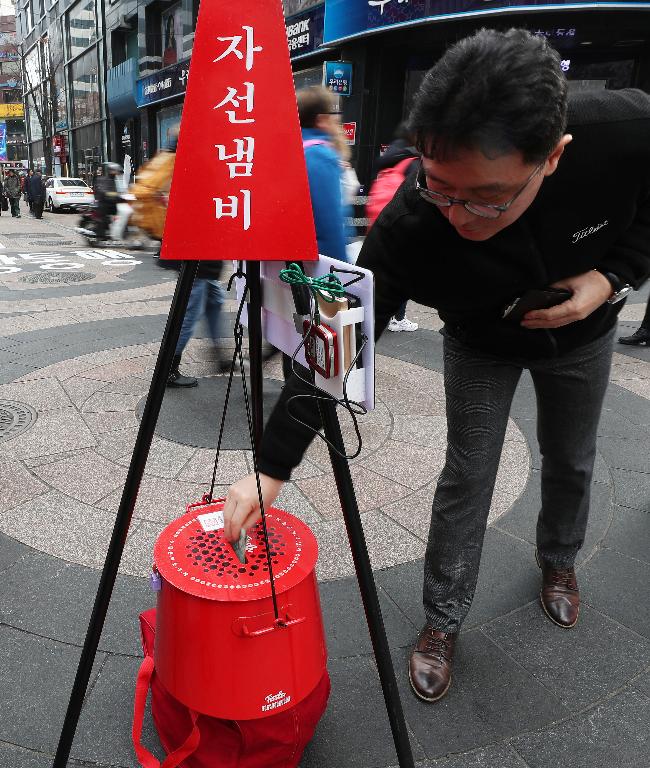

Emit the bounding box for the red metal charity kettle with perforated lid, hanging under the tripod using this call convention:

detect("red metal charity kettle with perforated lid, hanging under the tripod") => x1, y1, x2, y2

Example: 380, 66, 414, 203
154, 500, 327, 720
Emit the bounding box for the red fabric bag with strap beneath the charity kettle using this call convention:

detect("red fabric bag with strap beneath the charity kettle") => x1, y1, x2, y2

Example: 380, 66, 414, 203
132, 608, 330, 768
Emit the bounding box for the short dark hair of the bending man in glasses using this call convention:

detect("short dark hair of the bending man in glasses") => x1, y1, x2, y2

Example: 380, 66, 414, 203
410, 29, 568, 163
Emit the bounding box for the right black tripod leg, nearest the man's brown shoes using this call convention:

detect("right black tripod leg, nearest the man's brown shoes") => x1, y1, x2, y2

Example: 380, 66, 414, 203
318, 401, 415, 768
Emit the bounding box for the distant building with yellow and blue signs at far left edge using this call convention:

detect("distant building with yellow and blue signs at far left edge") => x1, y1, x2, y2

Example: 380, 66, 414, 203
0, 3, 27, 170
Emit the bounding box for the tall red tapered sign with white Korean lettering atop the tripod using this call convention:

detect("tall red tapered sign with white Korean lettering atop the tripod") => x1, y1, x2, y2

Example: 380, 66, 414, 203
161, 0, 318, 261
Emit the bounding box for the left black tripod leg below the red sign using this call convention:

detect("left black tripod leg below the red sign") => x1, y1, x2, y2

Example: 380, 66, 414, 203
52, 262, 198, 768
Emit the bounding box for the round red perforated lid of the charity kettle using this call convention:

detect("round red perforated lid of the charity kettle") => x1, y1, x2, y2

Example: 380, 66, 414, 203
154, 501, 318, 601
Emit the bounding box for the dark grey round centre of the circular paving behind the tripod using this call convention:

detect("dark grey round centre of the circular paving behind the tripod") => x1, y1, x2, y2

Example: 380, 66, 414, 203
135, 374, 282, 450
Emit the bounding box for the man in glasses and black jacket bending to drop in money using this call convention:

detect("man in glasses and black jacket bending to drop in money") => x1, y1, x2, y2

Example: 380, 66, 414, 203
224, 29, 650, 702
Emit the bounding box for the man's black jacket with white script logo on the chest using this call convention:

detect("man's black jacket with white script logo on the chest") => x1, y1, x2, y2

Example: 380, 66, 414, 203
260, 89, 650, 479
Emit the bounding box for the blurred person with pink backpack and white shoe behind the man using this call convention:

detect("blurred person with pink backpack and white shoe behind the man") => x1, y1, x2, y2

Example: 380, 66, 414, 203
366, 122, 420, 333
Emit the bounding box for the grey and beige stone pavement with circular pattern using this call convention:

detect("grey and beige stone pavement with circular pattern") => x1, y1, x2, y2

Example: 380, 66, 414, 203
0, 214, 650, 768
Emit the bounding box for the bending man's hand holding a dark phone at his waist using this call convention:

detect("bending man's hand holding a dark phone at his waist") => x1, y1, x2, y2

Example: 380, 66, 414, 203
521, 269, 612, 328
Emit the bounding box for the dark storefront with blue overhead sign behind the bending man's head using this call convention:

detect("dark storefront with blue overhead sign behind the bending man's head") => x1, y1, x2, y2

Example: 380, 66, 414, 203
285, 0, 650, 183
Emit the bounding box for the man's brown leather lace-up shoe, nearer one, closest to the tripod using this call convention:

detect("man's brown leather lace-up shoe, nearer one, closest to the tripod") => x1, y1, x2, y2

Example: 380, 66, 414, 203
409, 624, 456, 701
